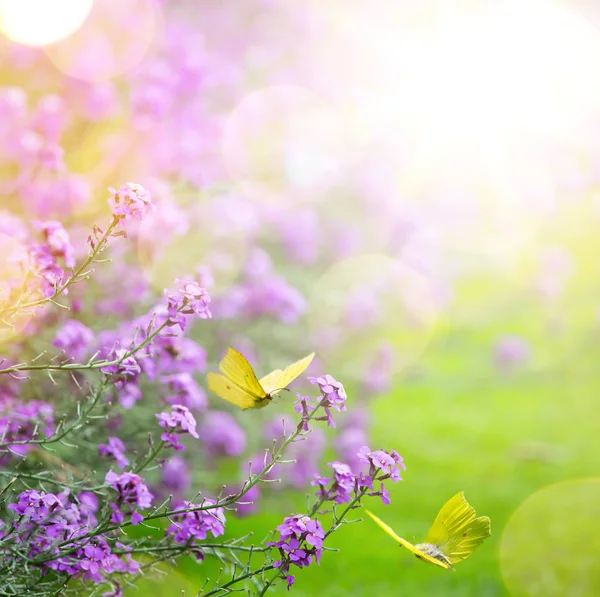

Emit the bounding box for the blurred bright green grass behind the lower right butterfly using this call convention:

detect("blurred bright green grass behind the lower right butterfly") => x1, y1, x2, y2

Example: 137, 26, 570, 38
133, 207, 600, 597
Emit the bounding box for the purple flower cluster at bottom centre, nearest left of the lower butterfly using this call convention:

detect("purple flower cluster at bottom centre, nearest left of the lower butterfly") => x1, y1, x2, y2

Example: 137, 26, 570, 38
267, 514, 325, 588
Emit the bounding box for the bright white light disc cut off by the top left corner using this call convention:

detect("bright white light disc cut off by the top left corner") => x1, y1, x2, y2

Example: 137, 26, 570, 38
0, 0, 93, 46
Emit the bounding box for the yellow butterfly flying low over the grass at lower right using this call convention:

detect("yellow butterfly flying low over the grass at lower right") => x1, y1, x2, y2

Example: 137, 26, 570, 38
367, 491, 491, 570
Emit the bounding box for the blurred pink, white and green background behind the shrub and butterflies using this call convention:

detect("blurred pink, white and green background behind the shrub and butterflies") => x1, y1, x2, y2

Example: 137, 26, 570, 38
0, 0, 600, 597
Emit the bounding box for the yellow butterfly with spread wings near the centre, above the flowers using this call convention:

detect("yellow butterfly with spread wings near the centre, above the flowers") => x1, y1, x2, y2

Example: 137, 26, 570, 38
208, 348, 315, 410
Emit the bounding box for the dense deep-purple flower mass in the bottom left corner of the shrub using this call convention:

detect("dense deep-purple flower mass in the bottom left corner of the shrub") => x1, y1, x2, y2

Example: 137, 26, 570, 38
8, 490, 140, 583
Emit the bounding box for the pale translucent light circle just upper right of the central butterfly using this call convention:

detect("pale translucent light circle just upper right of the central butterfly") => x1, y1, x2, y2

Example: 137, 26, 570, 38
308, 254, 439, 380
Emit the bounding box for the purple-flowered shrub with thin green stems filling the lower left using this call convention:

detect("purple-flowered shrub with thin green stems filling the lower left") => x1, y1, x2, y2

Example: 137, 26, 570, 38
0, 184, 404, 595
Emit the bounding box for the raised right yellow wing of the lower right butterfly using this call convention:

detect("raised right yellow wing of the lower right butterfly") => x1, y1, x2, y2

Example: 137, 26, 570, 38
425, 491, 491, 563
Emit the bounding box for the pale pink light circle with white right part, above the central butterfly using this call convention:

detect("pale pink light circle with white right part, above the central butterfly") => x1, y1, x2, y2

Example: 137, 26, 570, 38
222, 85, 344, 204
